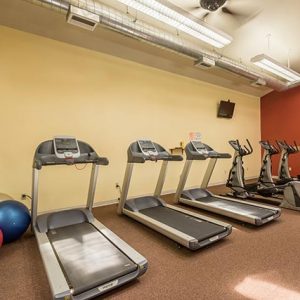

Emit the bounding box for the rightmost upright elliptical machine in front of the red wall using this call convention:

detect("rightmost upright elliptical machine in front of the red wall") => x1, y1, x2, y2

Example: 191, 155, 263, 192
276, 141, 299, 184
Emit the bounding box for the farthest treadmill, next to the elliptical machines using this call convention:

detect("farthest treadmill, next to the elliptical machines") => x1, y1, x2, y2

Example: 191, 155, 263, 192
175, 140, 281, 226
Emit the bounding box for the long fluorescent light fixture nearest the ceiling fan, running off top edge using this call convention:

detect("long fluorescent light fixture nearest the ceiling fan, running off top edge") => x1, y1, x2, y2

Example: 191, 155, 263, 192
118, 0, 232, 48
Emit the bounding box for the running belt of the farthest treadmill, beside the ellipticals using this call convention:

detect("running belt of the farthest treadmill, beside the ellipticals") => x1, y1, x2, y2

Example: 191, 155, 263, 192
196, 196, 275, 219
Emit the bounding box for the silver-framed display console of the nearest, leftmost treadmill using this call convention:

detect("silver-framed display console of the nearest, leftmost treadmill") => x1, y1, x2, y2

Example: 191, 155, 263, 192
53, 136, 80, 159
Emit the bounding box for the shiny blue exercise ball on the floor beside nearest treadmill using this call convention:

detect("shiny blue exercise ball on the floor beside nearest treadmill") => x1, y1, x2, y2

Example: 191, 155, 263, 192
0, 200, 31, 244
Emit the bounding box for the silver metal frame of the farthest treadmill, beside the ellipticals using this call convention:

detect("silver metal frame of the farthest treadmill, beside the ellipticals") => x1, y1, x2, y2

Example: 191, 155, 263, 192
175, 158, 281, 226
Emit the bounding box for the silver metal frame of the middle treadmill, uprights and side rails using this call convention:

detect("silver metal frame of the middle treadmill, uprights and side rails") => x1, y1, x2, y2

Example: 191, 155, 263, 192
118, 160, 232, 250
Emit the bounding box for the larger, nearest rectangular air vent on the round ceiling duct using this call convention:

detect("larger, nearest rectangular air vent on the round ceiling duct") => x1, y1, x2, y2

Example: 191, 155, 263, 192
67, 5, 100, 31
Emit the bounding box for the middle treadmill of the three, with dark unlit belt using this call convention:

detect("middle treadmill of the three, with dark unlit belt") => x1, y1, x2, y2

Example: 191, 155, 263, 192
118, 140, 232, 250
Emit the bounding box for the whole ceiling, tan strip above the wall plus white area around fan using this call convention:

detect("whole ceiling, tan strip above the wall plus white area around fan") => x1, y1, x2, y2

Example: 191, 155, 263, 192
0, 0, 300, 96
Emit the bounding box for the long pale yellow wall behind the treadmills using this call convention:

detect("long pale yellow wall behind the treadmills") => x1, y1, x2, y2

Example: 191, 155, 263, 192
0, 27, 260, 210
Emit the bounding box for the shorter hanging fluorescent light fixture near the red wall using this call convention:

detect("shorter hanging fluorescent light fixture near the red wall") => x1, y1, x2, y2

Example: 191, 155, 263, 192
251, 54, 300, 83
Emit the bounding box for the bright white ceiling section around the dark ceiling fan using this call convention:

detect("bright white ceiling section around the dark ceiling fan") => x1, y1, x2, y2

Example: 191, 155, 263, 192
170, 0, 300, 72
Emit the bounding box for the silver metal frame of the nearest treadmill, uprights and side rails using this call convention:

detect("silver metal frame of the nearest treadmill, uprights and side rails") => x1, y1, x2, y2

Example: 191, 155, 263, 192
31, 147, 147, 300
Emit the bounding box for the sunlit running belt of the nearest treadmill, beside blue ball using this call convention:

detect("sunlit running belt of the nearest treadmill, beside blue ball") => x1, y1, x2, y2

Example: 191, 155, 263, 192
48, 223, 137, 295
